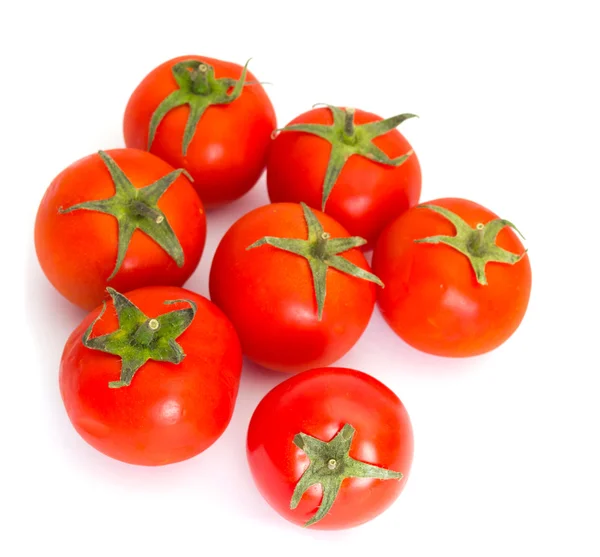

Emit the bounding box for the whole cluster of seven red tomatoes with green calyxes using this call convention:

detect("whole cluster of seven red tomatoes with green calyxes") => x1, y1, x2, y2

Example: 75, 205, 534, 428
35, 56, 531, 528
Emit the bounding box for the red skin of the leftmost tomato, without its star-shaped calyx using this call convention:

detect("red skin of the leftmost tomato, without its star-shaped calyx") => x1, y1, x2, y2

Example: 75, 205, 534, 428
35, 149, 206, 310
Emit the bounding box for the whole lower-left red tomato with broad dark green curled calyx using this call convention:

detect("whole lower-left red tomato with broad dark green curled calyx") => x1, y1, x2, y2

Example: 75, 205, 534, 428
60, 286, 242, 466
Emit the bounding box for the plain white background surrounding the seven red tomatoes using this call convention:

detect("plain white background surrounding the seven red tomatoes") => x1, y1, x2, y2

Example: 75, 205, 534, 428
0, 0, 600, 557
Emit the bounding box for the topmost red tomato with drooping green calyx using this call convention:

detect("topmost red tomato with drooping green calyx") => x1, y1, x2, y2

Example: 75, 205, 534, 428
123, 56, 276, 207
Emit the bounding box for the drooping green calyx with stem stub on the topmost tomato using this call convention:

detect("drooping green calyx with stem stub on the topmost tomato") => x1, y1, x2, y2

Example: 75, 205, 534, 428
148, 60, 250, 156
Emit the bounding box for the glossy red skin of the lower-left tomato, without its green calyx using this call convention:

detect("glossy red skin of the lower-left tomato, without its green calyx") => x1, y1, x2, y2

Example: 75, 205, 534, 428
60, 286, 242, 466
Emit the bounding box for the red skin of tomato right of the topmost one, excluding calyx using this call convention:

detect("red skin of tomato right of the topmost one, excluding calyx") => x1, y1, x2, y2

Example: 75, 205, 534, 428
267, 108, 421, 248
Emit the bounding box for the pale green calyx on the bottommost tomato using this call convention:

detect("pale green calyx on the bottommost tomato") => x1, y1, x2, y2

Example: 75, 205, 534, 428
290, 424, 402, 526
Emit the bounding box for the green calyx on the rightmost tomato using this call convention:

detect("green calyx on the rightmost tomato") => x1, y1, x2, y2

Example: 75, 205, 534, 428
415, 205, 527, 285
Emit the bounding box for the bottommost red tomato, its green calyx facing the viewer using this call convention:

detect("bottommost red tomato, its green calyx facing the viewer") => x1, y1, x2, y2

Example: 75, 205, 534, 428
247, 368, 413, 529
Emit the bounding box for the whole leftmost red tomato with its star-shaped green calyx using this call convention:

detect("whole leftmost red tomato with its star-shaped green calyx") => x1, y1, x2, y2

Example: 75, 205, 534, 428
35, 149, 206, 310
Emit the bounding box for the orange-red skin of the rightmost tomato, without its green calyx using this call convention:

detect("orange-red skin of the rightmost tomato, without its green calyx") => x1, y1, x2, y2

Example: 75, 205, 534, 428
373, 198, 531, 357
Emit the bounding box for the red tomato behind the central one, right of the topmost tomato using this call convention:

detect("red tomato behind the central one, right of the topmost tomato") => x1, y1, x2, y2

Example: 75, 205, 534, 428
267, 107, 421, 243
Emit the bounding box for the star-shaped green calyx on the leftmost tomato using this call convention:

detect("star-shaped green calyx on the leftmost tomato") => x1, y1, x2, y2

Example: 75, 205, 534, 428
59, 151, 191, 280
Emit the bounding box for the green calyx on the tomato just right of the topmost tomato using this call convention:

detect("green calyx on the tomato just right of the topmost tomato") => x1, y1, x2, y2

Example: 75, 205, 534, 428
277, 105, 416, 211
